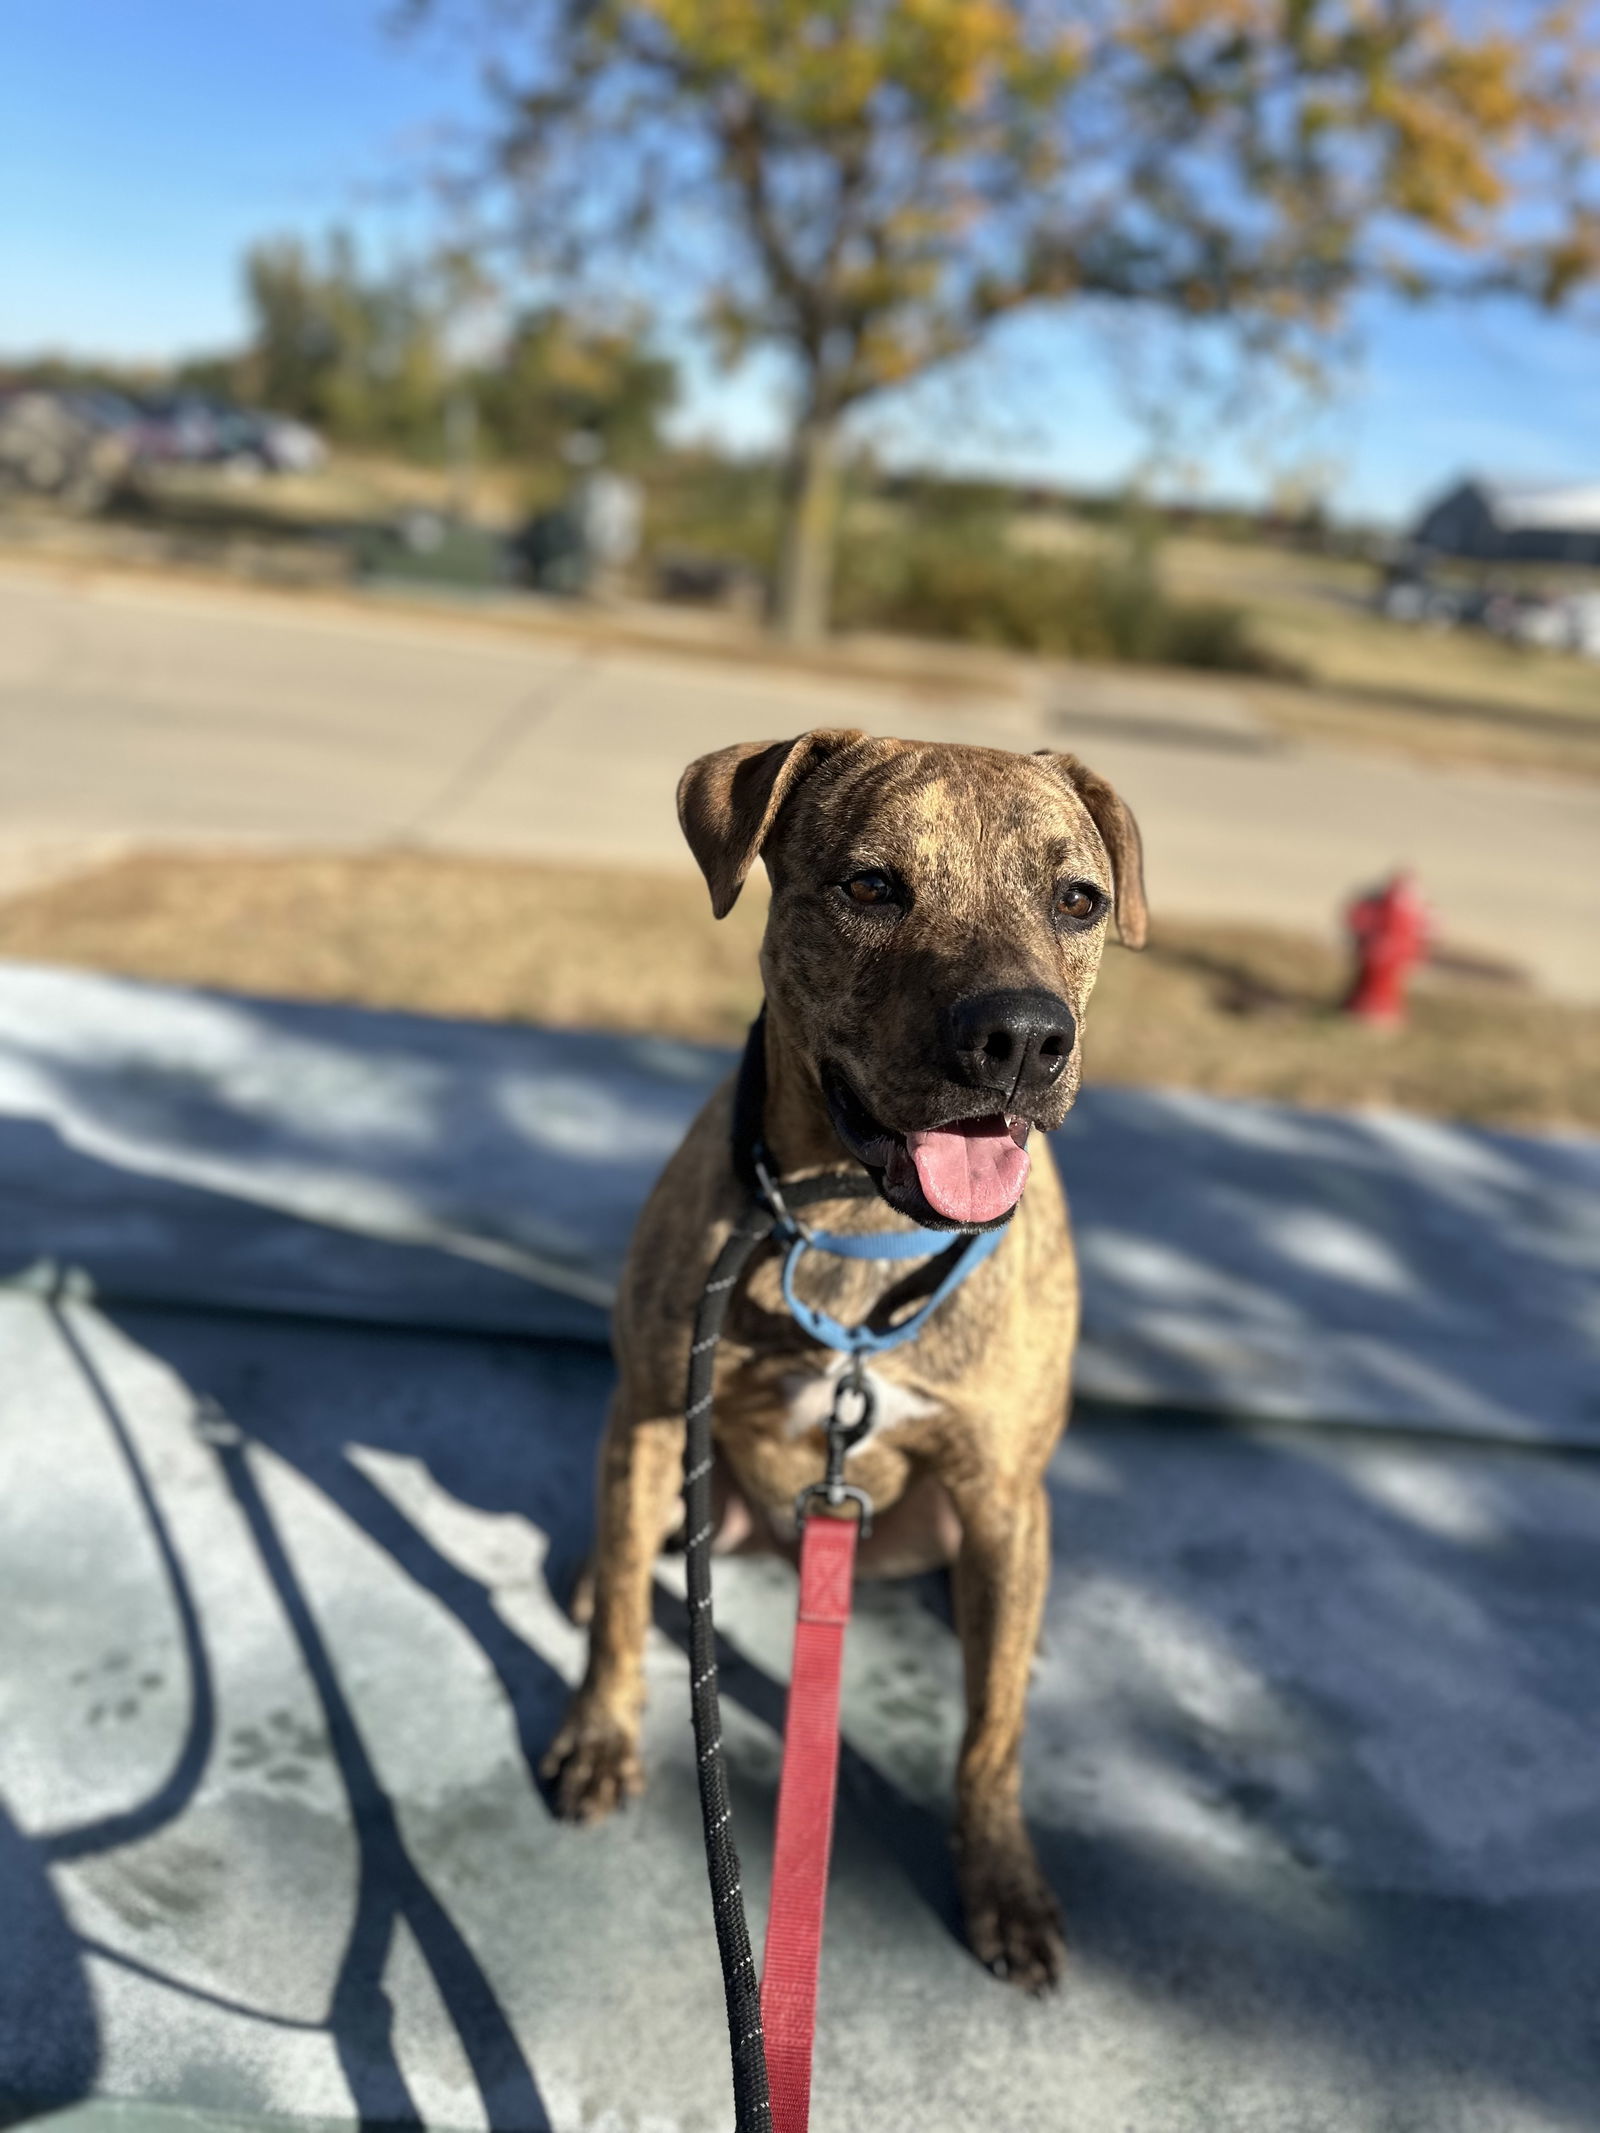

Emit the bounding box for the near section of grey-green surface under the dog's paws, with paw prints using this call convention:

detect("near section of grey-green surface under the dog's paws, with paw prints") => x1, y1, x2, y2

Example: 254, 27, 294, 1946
0, 1297, 1600, 2133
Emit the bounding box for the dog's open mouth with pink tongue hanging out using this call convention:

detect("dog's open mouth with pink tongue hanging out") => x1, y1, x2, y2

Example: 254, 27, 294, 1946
823, 1067, 1033, 1229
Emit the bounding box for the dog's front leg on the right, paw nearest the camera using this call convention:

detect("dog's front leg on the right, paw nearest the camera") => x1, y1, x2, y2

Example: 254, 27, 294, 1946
956, 1485, 1067, 1992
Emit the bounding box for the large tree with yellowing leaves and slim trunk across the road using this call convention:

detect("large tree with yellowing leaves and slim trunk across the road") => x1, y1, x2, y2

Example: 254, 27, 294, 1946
412, 0, 1600, 638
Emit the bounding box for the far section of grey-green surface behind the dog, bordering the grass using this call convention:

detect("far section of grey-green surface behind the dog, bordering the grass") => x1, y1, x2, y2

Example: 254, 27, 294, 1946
0, 964, 1600, 1448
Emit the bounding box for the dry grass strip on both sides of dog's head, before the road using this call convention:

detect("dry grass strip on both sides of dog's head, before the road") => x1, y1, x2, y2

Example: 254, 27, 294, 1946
0, 853, 1600, 1128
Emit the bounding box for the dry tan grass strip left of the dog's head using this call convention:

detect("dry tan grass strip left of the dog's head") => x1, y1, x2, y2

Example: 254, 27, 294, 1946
0, 851, 762, 1041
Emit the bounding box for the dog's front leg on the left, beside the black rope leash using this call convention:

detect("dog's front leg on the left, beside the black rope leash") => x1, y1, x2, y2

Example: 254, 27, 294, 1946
540, 1389, 683, 1822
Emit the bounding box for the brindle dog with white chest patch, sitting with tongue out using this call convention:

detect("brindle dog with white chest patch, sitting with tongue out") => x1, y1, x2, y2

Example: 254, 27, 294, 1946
546, 732, 1146, 1990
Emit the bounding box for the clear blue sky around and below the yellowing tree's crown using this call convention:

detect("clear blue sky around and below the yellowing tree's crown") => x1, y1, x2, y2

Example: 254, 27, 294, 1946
0, 0, 1600, 518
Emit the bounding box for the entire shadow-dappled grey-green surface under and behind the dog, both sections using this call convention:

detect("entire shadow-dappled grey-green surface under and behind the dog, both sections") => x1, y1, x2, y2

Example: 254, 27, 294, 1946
0, 971, 1600, 2133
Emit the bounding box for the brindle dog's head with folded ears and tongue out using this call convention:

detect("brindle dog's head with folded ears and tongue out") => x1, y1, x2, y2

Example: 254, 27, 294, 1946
678, 732, 1146, 1229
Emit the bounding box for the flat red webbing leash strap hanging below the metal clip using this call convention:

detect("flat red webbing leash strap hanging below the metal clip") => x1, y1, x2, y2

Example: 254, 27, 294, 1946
762, 1512, 858, 2133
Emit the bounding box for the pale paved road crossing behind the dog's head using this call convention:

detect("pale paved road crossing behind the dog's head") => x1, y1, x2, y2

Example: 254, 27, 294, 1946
0, 565, 1600, 998
